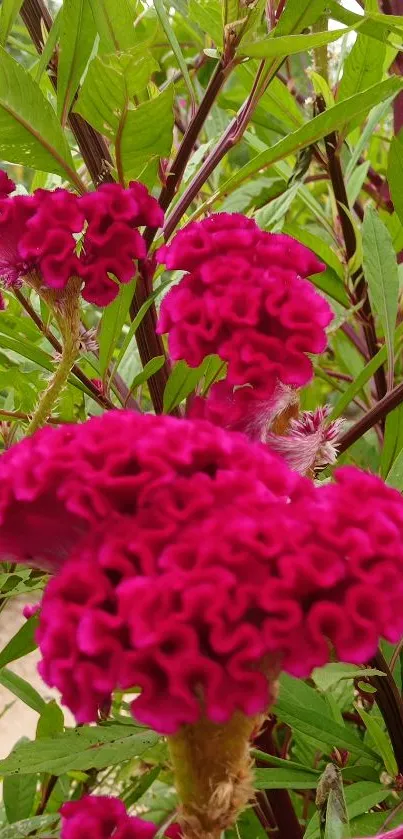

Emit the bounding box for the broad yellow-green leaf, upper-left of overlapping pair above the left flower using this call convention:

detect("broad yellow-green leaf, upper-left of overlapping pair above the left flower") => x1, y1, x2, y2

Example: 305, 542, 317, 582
74, 48, 158, 141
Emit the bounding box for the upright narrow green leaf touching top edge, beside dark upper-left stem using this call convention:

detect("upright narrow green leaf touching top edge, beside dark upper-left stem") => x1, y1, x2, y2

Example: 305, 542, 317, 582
57, 0, 95, 125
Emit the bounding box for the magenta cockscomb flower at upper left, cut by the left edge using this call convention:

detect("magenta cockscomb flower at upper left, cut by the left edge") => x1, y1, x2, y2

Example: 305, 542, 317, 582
0, 172, 163, 306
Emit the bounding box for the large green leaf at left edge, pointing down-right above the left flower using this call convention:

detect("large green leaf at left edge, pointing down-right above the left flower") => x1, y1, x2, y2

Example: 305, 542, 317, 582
0, 48, 81, 185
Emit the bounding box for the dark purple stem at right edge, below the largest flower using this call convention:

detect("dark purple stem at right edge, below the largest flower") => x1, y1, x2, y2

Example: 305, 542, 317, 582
370, 649, 403, 773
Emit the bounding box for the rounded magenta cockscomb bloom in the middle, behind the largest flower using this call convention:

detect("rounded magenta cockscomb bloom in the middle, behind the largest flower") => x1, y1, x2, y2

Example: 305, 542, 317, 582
158, 213, 333, 399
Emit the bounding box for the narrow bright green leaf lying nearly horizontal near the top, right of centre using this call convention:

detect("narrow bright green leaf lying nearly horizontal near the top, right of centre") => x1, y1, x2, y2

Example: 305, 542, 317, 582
238, 26, 357, 58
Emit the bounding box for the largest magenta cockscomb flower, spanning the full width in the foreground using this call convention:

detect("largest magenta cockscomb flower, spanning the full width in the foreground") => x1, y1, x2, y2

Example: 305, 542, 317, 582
0, 412, 403, 733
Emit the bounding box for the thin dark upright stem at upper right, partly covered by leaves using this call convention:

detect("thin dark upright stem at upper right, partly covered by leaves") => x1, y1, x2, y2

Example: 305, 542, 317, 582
316, 96, 387, 400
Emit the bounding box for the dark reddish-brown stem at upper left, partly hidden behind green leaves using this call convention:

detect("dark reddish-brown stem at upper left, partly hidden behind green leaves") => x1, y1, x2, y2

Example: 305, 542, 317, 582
20, 0, 113, 186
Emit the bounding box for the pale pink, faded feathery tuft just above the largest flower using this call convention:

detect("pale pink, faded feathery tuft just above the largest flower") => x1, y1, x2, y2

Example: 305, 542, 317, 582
265, 406, 344, 475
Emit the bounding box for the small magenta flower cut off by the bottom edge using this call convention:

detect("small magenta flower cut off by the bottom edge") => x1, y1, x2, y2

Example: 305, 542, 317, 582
60, 795, 180, 839
